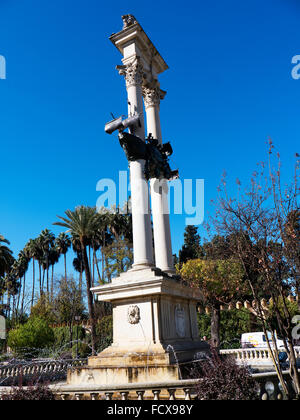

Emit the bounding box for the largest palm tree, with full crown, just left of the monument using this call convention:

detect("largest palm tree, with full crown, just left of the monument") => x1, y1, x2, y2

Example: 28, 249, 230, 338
54, 206, 101, 355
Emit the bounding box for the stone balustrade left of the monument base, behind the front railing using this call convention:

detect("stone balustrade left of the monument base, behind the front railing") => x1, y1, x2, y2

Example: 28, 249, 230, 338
0, 359, 87, 386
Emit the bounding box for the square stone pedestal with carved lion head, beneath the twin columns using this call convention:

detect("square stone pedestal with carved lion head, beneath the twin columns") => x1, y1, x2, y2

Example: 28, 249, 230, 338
68, 268, 209, 385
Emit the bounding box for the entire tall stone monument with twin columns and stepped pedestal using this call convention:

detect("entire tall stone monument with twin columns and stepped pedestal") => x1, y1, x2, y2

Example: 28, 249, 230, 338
68, 15, 208, 385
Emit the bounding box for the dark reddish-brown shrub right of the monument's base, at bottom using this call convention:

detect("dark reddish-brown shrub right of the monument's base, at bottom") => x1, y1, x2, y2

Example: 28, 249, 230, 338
192, 354, 259, 401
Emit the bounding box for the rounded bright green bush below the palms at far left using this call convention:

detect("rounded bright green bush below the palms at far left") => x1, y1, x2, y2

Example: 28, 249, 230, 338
7, 318, 54, 354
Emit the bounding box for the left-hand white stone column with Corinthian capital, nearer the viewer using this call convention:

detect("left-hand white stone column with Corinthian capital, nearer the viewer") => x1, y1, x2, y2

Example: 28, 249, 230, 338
120, 59, 153, 269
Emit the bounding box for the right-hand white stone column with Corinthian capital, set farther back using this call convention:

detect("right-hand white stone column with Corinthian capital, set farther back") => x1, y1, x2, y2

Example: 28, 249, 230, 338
143, 83, 175, 274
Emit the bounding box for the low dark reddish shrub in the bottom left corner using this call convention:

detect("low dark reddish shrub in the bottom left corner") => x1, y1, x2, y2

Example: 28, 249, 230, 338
0, 384, 55, 401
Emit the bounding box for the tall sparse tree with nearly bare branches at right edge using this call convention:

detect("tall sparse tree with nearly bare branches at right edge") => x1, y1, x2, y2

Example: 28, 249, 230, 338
212, 140, 300, 398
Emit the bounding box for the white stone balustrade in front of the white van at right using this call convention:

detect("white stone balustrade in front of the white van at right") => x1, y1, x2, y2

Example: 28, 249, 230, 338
221, 347, 300, 365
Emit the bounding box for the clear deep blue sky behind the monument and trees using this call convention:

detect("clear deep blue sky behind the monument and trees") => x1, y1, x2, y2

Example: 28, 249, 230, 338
0, 0, 300, 276
